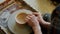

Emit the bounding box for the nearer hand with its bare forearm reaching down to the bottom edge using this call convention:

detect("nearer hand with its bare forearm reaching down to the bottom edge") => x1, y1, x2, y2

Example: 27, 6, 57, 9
25, 14, 42, 34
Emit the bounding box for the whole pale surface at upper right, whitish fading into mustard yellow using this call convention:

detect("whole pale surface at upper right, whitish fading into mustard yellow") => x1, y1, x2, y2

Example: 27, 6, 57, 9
24, 0, 55, 14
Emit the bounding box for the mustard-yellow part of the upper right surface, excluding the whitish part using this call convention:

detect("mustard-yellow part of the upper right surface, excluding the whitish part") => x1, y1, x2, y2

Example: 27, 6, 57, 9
38, 0, 55, 13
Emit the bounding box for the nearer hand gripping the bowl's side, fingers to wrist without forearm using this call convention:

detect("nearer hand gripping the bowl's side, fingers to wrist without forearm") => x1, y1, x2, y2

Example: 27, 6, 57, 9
25, 14, 39, 28
